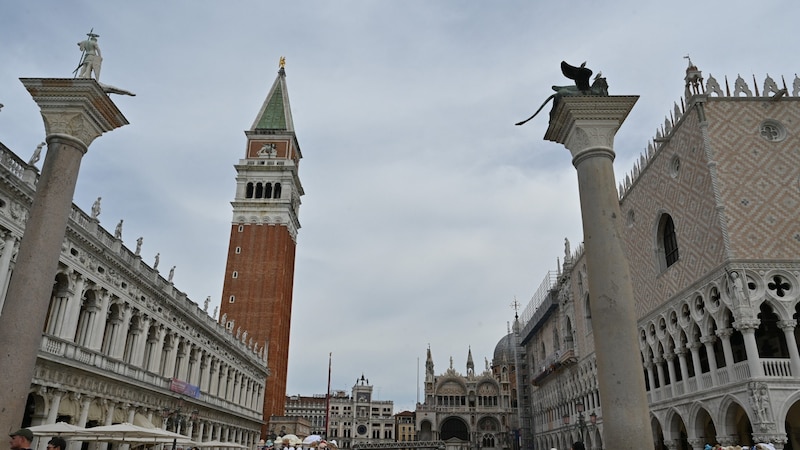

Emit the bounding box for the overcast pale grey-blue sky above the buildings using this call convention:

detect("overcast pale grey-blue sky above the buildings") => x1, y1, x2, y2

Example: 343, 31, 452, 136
0, 0, 800, 411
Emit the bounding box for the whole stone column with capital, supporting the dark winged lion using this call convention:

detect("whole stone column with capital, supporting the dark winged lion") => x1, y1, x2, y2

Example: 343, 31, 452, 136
545, 95, 653, 449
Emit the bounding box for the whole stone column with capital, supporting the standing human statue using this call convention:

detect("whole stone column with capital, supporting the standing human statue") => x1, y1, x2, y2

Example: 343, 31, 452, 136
0, 78, 128, 430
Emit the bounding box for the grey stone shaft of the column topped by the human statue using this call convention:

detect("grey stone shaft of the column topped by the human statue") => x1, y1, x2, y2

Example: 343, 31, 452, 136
0, 135, 87, 429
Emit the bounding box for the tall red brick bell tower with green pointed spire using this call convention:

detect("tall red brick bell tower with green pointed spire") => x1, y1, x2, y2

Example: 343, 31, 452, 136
220, 58, 303, 436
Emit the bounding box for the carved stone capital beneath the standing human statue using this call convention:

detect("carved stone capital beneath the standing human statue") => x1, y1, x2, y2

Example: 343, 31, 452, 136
20, 78, 128, 147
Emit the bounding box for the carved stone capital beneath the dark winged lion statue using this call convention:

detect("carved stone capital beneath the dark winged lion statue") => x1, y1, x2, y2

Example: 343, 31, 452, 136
544, 95, 639, 164
